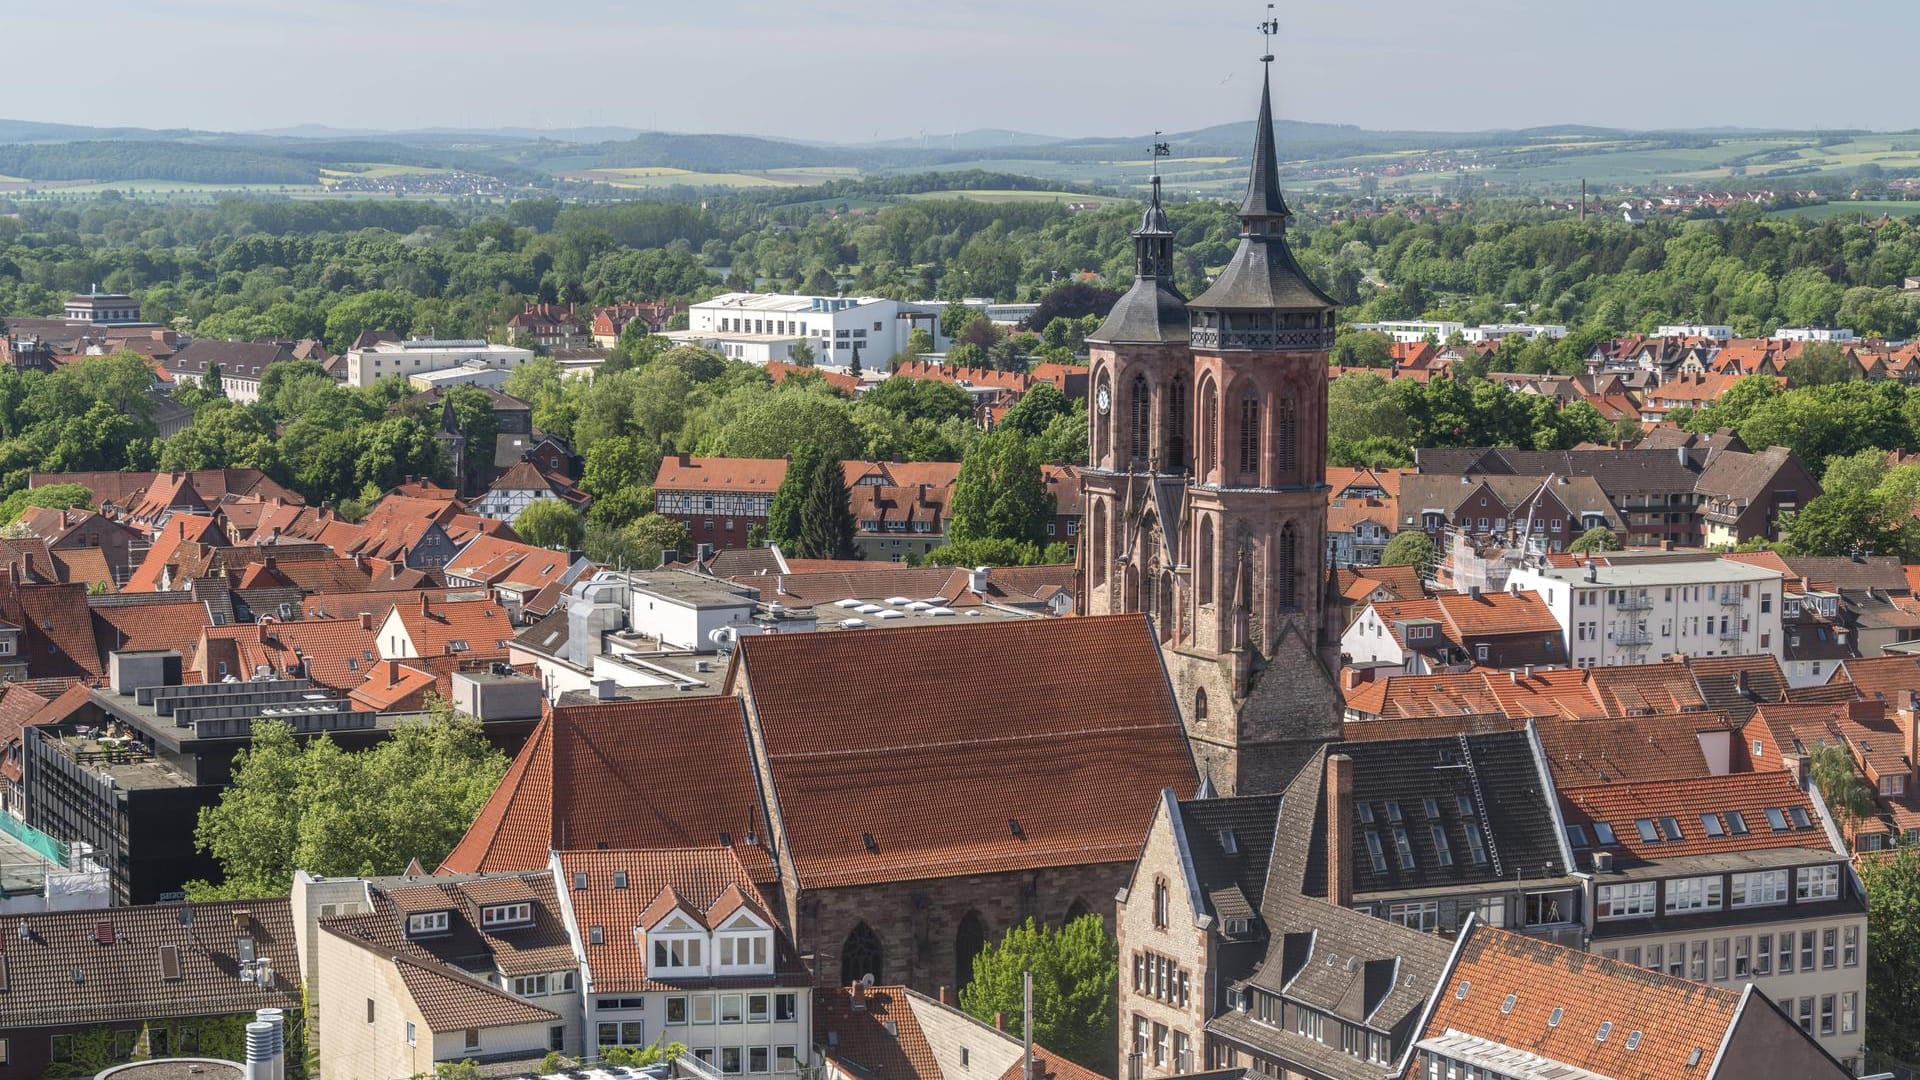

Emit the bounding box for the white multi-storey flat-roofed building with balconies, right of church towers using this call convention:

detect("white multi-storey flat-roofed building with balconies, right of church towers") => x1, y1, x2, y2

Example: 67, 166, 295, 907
1507, 553, 1786, 667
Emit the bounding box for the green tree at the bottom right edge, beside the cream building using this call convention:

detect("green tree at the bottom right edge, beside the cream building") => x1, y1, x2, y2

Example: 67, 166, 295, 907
1859, 844, 1920, 1068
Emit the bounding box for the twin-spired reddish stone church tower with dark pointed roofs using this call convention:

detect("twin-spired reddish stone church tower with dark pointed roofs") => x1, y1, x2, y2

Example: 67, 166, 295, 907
1081, 56, 1340, 794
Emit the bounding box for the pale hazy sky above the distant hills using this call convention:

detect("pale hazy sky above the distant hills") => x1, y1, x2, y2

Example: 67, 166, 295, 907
15, 0, 1920, 140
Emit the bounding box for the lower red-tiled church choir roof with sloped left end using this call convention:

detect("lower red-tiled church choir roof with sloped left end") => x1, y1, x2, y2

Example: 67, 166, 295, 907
442, 691, 775, 880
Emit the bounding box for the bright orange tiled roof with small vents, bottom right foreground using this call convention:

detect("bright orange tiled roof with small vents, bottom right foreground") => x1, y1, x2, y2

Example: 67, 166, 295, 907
1425, 914, 1740, 1080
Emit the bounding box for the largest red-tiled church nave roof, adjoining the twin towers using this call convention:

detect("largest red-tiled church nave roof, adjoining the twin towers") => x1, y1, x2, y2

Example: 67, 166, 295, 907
728, 615, 1196, 888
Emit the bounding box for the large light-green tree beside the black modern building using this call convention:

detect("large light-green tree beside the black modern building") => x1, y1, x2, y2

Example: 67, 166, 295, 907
188, 703, 507, 899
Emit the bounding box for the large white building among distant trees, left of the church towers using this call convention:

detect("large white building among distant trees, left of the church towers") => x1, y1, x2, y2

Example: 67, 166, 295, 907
666, 292, 948, 371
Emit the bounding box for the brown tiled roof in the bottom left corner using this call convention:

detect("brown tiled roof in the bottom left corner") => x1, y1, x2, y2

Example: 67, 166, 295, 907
0, 897, 301, 1028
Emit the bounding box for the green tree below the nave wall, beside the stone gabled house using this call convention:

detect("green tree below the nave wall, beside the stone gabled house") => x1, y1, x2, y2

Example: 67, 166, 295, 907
960, 915, 1119, 1076
